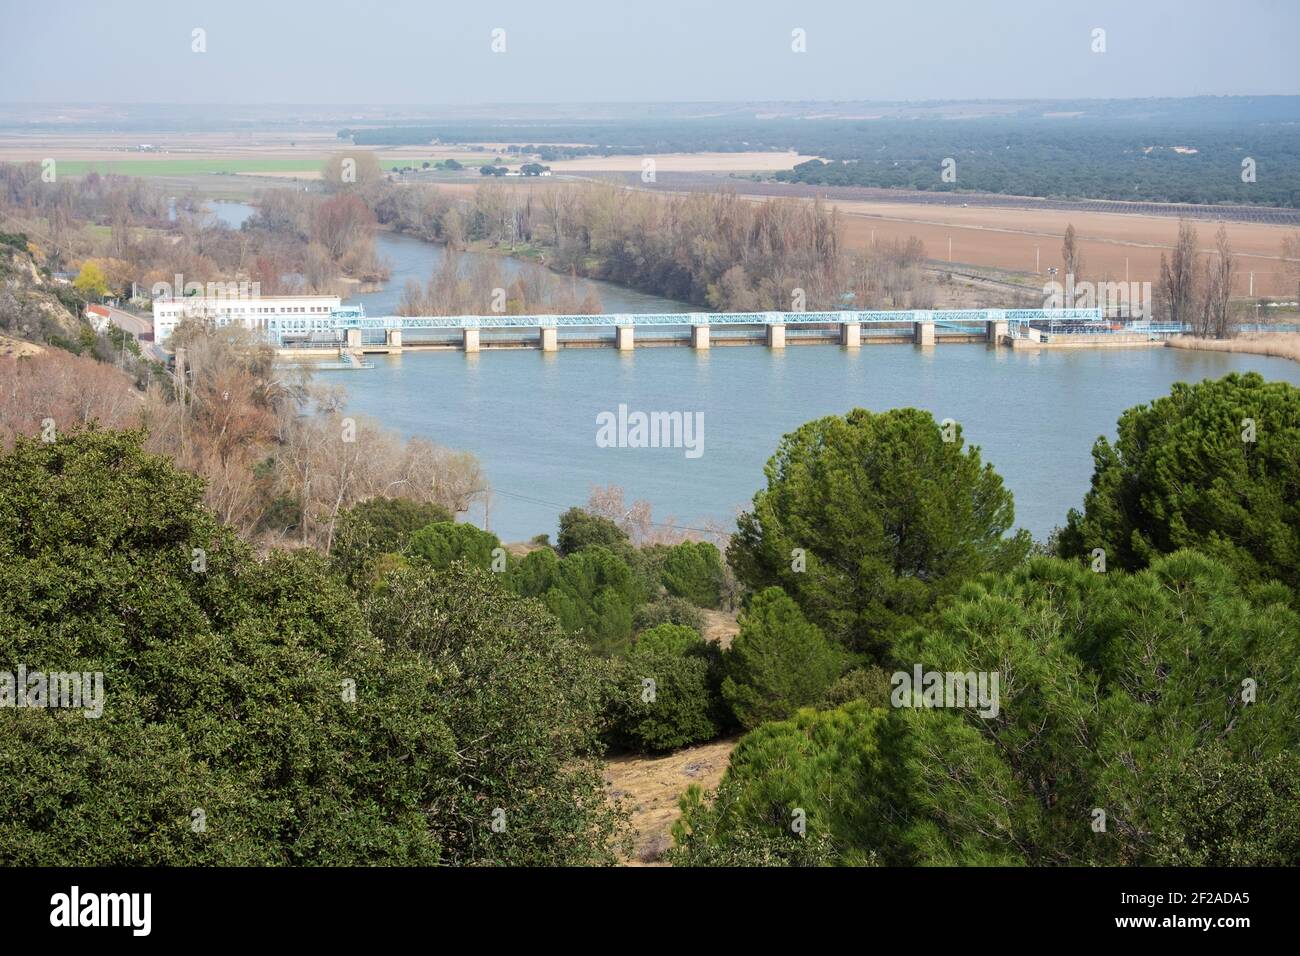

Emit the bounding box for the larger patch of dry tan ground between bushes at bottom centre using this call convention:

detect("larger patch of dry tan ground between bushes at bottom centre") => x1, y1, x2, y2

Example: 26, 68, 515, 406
605, 737, 738, 866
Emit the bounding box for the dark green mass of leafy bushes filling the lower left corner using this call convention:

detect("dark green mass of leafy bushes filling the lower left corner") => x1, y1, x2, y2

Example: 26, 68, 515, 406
0, 432, 618, 866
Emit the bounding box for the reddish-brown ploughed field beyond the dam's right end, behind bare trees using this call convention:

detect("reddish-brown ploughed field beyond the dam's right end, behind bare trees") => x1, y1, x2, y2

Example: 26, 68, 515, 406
832, 202, 1296, 297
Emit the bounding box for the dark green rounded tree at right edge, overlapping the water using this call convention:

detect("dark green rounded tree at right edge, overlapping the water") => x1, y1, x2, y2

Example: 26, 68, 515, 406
1058, 372, 1300, 591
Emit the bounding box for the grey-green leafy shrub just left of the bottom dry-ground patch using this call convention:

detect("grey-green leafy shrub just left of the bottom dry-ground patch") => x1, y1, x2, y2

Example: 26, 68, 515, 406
368, 563, 629, 865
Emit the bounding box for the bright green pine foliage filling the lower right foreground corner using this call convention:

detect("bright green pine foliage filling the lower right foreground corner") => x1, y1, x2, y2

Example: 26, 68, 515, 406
679, 551, 1300, 865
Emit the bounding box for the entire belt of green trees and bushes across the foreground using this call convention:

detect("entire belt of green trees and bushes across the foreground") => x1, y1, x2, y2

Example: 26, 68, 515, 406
0, 376, 1300, 866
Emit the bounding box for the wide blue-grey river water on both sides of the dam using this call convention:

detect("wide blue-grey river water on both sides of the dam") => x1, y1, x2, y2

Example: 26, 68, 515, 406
216, 204, 1300, 541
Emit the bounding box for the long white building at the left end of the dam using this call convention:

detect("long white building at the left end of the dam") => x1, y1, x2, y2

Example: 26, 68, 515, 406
153, 295, 342, 345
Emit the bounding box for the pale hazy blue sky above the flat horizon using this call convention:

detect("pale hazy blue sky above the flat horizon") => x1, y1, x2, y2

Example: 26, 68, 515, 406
0, 0, 1300, 104
